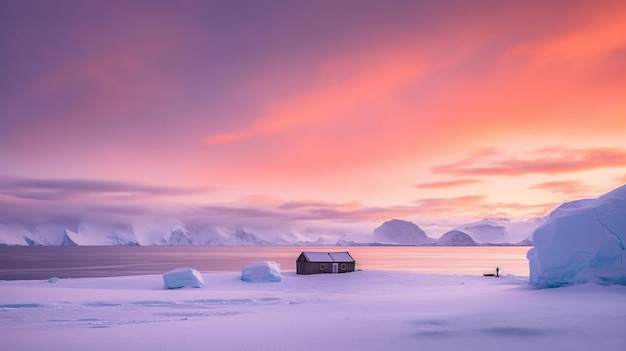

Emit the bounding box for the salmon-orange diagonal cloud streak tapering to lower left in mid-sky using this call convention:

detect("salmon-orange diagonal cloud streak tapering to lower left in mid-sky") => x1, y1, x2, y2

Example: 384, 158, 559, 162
205, 50, 425, 144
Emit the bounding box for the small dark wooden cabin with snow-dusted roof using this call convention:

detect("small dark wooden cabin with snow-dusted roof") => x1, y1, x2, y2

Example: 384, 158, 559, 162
296, 252, 356, 274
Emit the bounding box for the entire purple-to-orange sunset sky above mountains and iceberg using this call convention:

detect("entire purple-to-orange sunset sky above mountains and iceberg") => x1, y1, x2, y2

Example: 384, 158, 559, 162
0, 0, 626, 233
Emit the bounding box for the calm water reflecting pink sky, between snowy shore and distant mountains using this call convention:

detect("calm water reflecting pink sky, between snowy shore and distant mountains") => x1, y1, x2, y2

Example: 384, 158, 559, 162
0, 246, 530, 280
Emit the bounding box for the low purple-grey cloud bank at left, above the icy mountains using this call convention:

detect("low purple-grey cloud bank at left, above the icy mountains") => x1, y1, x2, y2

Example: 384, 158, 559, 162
0, 176, 215, 224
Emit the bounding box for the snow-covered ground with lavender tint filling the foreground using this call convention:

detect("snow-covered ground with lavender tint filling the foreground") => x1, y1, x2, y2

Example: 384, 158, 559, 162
0, 271, 626, 351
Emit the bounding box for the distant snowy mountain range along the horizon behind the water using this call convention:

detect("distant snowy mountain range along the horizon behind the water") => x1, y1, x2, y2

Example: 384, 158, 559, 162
0, 219, 541, 246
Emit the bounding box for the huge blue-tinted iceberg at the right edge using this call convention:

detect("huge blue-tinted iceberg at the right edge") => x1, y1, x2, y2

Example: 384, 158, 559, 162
527, 185, 626, 287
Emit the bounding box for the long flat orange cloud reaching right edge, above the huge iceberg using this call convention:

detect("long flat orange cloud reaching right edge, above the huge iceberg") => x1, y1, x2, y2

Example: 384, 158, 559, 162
432, 147, 626, 176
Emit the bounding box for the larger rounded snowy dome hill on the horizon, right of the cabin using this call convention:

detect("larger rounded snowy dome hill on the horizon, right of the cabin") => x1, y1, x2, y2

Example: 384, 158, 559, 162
372, 219, 433, 245
